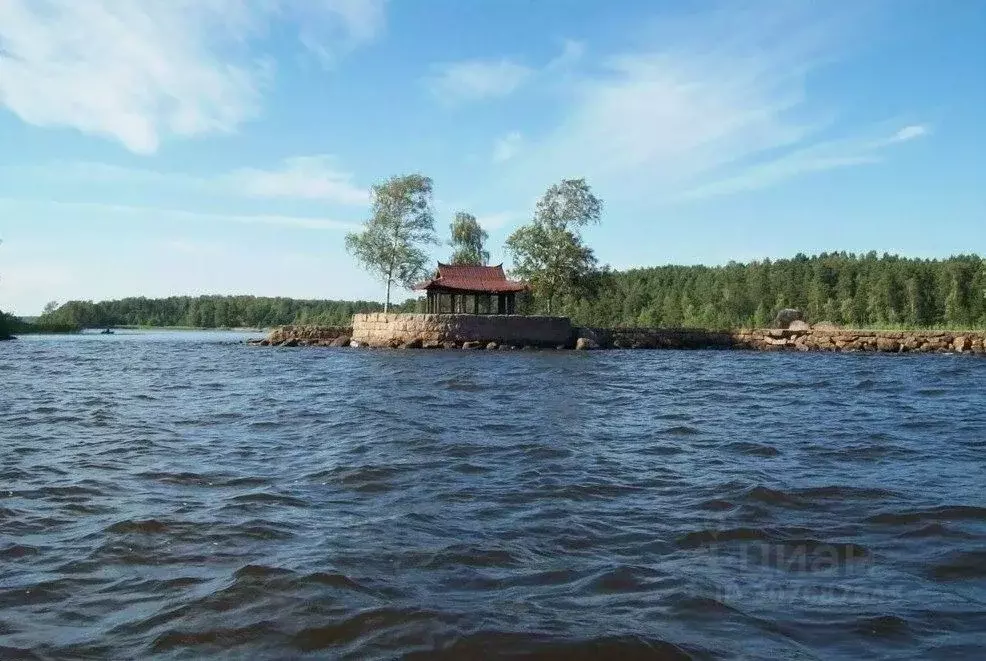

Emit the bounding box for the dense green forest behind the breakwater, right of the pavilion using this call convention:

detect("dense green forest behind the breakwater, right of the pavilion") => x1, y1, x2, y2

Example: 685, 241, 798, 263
562, 252, 986, 328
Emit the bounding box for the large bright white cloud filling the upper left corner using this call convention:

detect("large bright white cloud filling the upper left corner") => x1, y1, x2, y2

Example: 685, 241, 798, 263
0, 0, 384, 153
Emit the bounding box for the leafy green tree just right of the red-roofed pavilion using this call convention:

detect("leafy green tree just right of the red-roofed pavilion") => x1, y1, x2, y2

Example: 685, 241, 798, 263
506, 179, 602, 314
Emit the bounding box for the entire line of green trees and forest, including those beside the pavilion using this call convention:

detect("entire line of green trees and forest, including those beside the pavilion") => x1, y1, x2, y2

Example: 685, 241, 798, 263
9, 174, 986, 331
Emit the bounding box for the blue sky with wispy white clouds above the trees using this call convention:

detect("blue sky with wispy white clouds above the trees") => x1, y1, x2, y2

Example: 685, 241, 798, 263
0, 0, 986, 315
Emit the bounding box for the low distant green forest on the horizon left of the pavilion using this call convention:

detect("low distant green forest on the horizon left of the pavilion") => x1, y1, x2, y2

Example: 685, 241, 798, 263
36, 296, 392, 331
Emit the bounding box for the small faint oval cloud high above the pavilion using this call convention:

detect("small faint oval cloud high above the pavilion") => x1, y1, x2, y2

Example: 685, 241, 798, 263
429, 58, 534, 101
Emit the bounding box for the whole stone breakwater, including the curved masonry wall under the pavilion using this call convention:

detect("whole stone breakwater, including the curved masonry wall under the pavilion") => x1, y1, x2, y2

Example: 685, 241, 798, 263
253, 313, 986, 355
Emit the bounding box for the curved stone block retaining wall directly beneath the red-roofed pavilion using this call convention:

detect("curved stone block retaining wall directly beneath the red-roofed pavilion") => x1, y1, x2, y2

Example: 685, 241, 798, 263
352, 312, 572, 348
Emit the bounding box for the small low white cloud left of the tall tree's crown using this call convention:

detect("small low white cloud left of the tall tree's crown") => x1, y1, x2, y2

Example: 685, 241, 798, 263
226, 155, 370, 205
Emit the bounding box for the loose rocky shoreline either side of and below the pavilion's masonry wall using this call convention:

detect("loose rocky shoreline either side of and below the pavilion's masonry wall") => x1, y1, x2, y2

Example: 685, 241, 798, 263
251, 326, 986, 355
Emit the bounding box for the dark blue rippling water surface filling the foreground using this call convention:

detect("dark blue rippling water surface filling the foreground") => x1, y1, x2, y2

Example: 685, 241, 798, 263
0, 333, 986, 659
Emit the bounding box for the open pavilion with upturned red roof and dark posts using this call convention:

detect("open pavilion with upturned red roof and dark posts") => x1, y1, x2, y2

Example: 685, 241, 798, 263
415, 262, 527, 314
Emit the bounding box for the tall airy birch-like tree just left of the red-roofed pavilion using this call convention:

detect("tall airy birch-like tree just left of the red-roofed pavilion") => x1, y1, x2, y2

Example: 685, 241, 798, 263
346, 174, 437, 311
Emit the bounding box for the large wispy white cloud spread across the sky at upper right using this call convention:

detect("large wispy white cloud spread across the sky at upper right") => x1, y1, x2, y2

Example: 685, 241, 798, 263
503, 3, 926, 200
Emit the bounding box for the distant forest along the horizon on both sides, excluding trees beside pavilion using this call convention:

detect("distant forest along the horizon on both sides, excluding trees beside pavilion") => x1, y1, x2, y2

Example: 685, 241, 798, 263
30, 252, 986, 328
